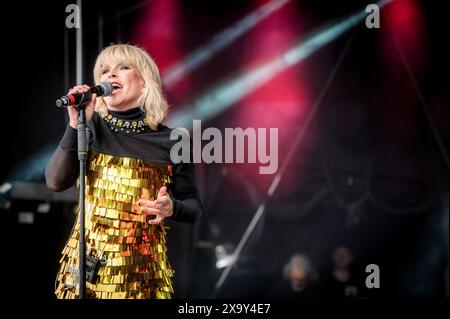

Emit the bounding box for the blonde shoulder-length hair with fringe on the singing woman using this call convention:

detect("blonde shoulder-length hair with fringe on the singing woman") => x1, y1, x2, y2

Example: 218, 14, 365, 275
94, 44, 169, 130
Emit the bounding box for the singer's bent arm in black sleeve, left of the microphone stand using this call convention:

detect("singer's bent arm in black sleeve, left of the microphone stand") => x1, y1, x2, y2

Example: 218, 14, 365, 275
45, 125, 79, 192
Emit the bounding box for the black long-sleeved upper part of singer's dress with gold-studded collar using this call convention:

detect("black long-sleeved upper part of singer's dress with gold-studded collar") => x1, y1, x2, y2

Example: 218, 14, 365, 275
55, 107, 202, 222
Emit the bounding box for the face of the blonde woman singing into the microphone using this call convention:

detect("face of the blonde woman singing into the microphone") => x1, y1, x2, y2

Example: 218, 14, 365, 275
100, 61, 144, 111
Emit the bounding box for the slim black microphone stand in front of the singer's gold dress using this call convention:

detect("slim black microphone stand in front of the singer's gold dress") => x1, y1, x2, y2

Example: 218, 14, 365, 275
77, 98, 88, 299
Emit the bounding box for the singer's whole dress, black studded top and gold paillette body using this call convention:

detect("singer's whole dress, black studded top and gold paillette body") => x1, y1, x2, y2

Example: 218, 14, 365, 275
51, 110, 199, 299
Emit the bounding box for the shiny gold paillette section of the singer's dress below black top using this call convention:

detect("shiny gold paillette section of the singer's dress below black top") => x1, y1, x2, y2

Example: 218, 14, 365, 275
55, 150, 174, 299
